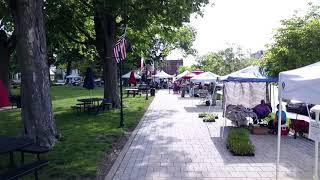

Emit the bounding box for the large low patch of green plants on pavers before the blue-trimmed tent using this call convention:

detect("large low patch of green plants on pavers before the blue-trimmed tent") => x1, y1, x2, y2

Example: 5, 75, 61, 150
227, 128, 254, 156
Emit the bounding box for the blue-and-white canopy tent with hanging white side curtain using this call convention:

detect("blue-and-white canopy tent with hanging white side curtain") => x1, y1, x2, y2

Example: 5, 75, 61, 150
218, 65, 278, 137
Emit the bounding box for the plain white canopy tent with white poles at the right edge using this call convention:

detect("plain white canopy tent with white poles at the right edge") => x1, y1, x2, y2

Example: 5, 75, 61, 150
276, 62, 320, 179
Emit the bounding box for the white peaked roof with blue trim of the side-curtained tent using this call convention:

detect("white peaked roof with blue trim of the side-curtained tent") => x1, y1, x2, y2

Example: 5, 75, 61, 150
219, 66, 278, 82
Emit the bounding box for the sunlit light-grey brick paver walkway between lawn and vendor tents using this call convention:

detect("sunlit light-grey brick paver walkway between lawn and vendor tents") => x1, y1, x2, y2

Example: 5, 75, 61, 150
108, 91, 320, 180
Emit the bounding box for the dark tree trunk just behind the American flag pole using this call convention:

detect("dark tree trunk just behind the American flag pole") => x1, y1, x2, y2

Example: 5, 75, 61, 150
94, 4, 120, 107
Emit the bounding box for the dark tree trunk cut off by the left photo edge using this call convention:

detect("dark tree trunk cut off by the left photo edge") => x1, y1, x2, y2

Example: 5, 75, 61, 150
0, 30, 11, 90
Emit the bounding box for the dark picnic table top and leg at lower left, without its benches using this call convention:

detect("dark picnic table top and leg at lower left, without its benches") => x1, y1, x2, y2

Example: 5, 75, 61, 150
0, 136, 33, 167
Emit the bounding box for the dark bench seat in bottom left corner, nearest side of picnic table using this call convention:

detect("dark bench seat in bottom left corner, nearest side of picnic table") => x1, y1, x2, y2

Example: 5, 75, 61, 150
0, 160, 49, 180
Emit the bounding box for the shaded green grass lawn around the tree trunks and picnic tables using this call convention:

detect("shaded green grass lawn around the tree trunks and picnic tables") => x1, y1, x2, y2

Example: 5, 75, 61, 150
0, 86, 153, 179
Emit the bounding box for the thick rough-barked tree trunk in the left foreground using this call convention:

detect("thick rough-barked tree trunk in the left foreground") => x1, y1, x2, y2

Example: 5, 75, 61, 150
11, 0, 57, 146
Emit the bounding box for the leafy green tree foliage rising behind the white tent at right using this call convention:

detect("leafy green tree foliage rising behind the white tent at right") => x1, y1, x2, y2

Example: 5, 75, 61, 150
261, 5, 320, 76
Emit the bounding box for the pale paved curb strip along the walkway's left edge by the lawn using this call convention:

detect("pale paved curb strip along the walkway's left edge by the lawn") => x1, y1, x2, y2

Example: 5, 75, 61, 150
104, 101, 153, 180
